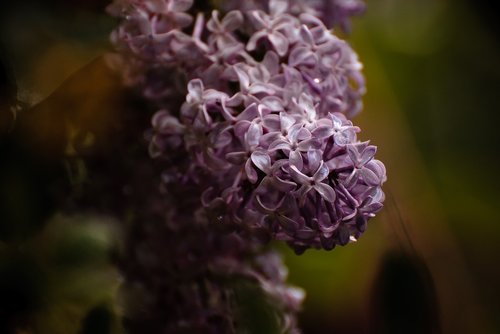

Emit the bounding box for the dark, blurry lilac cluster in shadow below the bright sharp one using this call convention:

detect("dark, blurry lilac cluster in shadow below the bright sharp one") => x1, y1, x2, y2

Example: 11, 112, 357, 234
119, 205, 304, 334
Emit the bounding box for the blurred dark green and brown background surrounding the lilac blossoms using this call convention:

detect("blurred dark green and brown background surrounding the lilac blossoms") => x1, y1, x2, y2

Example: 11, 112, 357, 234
0, 0, 500, 334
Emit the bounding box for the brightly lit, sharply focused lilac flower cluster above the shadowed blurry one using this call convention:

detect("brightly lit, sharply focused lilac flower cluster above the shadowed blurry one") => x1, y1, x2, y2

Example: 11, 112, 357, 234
107, 0, 386, 252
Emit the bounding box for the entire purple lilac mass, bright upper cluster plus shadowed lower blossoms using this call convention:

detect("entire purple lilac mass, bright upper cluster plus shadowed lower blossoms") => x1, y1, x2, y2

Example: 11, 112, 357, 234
108, 0, 386, 333
